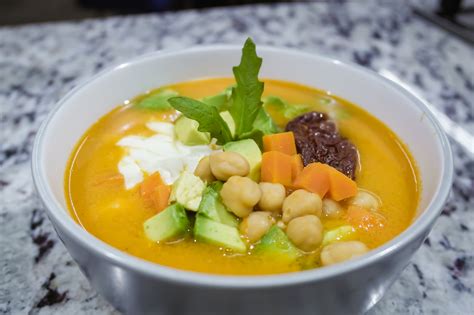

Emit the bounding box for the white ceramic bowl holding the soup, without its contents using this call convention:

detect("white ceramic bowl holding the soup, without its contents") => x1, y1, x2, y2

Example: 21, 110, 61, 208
32, 46, 452, 314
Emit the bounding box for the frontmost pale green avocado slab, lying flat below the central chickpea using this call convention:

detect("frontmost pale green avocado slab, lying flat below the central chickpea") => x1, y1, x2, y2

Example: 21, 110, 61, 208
194, 214, 247, 253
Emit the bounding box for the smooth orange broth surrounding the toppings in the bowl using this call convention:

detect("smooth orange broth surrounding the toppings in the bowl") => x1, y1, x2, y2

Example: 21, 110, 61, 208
64, 78, 420, 275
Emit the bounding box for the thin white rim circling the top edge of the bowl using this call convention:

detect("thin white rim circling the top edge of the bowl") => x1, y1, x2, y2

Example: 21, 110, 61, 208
31, 44, 453, 289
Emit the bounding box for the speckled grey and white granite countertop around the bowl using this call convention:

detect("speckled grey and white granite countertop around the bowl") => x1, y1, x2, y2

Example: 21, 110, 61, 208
0, 0, 474, 314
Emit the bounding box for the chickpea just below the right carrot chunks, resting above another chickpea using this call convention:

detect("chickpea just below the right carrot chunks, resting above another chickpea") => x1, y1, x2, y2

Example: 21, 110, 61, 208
283, 189, 322, 223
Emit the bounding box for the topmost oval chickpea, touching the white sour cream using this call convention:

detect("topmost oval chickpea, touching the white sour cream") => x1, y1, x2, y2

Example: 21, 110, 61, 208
209, 152, 250, 181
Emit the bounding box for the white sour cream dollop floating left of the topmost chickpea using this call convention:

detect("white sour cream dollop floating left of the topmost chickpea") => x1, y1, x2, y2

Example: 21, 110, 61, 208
117, 122, 212, 189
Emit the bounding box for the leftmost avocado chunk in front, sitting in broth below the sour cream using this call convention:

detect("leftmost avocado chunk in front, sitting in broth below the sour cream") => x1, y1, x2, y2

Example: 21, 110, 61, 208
143, 203, 190, 242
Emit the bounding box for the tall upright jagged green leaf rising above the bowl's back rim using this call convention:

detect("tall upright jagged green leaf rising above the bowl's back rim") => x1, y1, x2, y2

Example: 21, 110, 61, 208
229, 38, 263, 136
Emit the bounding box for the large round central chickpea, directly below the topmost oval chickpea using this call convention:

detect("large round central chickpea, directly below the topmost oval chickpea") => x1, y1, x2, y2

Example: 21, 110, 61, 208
221, 176, 262, 218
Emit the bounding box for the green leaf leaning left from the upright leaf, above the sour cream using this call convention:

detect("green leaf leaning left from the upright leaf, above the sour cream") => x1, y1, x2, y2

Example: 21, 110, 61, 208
168, 97, 232, 144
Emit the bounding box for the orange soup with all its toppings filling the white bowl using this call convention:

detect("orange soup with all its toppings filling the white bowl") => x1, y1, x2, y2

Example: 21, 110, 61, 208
65, 43, 420, 275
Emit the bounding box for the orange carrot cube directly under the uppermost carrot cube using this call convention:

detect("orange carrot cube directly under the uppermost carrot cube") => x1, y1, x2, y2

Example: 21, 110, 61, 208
260, 151, 291, 186
